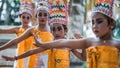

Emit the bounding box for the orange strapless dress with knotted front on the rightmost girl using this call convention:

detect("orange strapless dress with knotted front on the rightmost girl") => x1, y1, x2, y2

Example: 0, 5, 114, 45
87, 46, 118, 68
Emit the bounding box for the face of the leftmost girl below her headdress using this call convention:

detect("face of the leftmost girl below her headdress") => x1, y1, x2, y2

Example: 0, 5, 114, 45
20, 13, 31, 26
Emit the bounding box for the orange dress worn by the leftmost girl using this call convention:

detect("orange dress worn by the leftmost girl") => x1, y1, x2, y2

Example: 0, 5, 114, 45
17, 28, 33, 68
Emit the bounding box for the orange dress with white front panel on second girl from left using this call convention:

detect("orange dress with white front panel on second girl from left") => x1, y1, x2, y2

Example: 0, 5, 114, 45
28, 29, 53, 68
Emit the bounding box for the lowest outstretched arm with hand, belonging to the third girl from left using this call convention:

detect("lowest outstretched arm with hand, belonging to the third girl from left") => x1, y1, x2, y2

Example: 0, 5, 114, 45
2, 47, 47, 61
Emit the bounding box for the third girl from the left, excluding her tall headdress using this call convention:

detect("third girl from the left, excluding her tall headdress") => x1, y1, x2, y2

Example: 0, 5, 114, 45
1, 10, 85, 68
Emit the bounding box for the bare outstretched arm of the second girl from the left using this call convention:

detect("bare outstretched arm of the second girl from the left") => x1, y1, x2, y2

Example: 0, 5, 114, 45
0, 28, 32, 50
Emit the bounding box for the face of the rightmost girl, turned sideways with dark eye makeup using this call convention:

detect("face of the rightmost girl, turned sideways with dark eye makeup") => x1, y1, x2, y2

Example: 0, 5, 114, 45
92, 13, 111, 37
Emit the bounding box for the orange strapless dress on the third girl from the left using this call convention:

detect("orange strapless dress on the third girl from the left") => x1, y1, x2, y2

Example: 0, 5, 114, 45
54, 49, 70, 68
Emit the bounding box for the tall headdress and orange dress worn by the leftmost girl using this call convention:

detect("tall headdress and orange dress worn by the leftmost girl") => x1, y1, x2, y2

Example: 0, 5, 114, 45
17, 1, 34, 68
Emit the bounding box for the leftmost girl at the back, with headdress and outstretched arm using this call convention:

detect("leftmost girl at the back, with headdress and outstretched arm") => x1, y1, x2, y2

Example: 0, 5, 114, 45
0, 2, 32, 68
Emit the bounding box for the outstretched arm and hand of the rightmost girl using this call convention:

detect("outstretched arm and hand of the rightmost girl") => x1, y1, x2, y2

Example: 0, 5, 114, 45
34, 35, 87, 49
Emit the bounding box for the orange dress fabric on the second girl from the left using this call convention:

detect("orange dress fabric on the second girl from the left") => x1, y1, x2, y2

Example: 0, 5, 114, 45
28, 29, 54, 68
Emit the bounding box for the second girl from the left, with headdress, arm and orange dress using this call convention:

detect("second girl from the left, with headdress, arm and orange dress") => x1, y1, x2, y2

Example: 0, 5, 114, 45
0, 1, 53, 68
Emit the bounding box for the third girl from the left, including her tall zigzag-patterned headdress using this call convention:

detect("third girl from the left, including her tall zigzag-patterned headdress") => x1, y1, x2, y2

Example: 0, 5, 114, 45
1, 0, 86, 68
